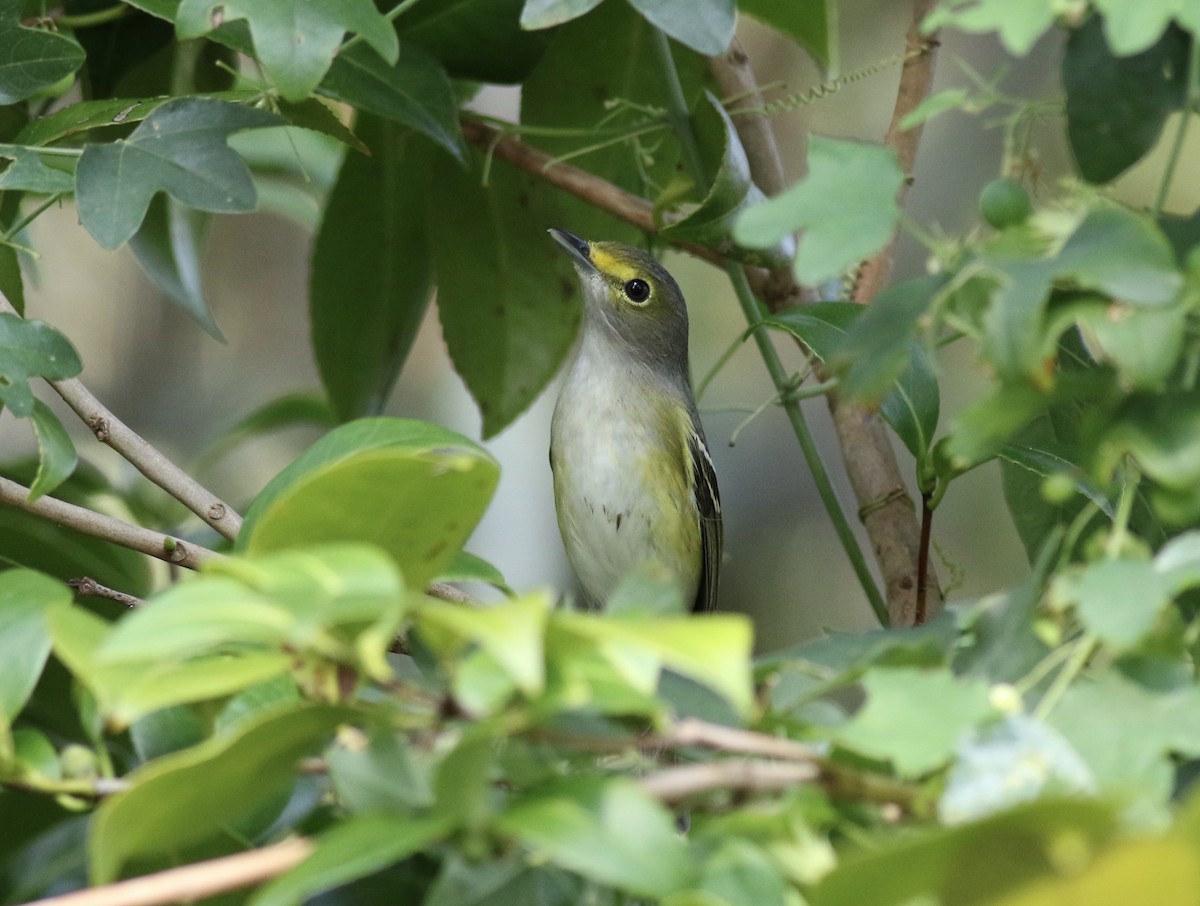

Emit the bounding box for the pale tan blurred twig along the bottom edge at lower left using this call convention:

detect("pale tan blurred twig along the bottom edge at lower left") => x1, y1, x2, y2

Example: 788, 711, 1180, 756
29, 838, 313, 906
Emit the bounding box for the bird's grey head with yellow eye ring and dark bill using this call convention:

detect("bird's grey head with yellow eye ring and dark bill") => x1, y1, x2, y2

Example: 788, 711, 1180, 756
550, 229, 688, 374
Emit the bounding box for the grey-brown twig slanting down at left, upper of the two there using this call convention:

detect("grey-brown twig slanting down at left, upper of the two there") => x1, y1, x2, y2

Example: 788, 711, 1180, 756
0, 293, 241, 540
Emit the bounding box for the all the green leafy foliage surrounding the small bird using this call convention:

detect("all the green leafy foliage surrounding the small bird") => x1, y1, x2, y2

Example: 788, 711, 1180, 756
0, 0, 1200, 906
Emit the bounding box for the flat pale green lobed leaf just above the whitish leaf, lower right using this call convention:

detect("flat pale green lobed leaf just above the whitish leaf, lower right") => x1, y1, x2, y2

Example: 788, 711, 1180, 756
834, 667, 992, 778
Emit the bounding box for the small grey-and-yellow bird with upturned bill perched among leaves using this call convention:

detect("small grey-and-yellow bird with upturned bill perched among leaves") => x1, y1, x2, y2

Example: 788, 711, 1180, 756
550, 229, 722, 611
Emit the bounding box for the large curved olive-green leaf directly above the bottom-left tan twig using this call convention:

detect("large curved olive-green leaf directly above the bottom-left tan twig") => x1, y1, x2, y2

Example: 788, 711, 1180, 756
88, 704, 354, 884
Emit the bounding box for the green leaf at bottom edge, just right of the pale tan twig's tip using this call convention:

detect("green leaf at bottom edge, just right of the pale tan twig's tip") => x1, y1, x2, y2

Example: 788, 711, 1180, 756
250, 815, 450, 906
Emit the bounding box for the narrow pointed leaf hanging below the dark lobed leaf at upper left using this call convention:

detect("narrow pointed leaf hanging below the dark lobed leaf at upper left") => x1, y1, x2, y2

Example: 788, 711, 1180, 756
130, 194, 224, 340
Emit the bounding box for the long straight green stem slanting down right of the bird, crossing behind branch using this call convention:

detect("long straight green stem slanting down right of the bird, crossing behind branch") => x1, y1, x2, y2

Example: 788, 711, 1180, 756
654, 29, 888, 626
